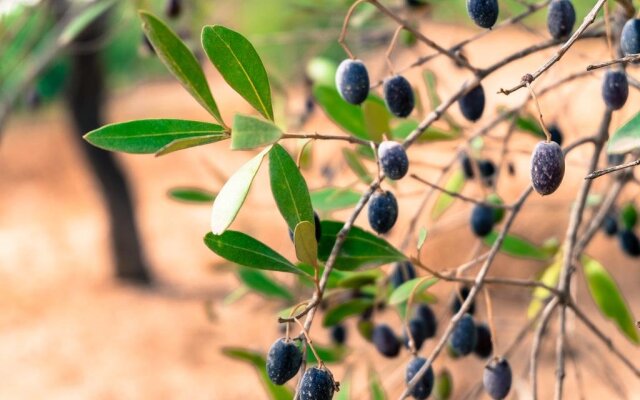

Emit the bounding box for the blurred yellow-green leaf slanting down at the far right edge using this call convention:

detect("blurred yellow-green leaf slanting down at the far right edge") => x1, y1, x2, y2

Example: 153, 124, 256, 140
582, 256, 640, 344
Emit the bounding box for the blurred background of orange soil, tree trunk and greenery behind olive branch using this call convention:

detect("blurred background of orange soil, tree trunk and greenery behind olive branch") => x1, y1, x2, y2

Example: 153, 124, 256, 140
0, 0, 640, 399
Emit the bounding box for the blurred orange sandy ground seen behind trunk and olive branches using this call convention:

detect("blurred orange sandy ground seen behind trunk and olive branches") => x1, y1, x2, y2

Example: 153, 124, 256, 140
0, 22, 640, 399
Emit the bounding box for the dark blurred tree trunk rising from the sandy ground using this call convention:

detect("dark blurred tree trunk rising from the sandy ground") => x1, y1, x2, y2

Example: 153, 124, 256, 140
52, 0, 151, 285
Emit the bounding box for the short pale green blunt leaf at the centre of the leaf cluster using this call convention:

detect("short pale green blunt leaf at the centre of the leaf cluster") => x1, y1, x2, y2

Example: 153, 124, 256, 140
231, 114, 282, 150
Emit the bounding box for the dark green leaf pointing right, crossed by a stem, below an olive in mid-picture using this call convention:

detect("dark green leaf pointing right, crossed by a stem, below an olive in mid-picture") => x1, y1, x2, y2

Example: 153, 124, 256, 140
318, 221, 406, 271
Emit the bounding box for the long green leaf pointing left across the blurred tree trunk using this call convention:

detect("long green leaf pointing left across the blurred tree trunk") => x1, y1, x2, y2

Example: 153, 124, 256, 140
84, 119, 228, 154
